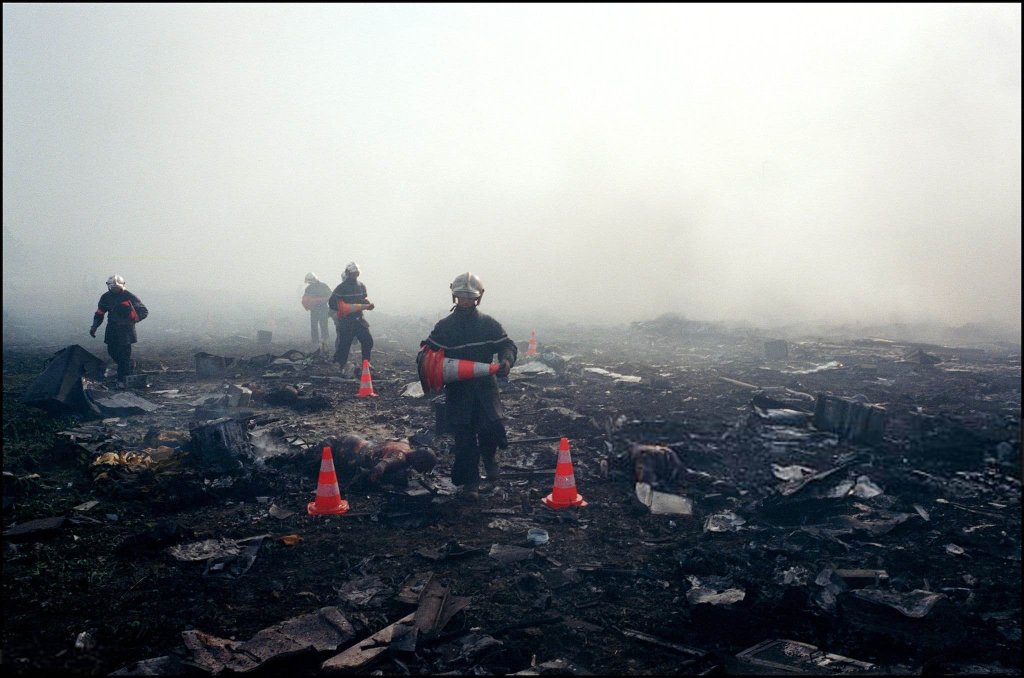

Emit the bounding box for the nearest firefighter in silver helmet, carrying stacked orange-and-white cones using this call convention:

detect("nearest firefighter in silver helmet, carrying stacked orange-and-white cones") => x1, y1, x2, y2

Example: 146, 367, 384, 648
417, 272, 518, 499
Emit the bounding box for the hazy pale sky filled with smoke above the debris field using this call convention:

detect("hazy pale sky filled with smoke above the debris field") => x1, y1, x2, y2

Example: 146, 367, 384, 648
3, 3, 1021, 328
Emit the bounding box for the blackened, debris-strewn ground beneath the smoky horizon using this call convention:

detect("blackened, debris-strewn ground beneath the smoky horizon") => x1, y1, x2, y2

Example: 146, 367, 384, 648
2, 321, 1021, 676
